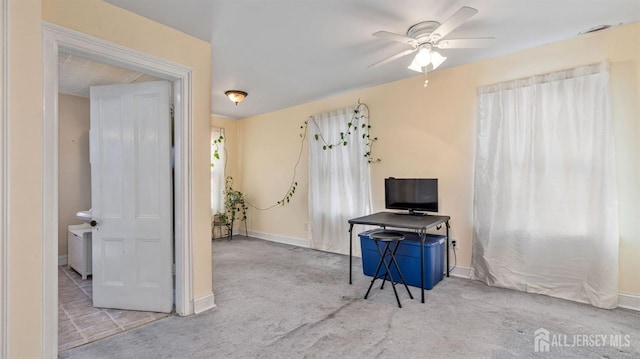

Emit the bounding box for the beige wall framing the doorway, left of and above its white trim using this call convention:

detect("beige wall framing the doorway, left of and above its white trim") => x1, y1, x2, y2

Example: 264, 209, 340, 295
3, 0, 212, 358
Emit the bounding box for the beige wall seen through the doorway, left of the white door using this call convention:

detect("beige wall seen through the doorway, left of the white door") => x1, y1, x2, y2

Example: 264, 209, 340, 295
58, 94, 91, 256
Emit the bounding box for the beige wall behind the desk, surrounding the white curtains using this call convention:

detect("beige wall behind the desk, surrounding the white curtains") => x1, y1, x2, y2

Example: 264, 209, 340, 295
239, 23, 640, 294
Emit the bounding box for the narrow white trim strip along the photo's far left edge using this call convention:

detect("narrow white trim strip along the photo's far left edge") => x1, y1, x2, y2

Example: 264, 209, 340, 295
0, 0, 9, 358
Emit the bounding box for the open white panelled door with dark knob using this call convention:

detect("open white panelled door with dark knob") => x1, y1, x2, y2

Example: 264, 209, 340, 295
90, 81, 173, 312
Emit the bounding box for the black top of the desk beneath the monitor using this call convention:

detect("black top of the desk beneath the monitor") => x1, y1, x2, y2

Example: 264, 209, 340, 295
349, 212, 451, 230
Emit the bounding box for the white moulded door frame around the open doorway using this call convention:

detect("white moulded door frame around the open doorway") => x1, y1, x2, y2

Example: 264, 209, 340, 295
41, 22, 193, 358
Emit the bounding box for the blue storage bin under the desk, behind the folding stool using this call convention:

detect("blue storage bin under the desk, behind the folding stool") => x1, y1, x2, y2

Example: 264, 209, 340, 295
358, 229, 447, 289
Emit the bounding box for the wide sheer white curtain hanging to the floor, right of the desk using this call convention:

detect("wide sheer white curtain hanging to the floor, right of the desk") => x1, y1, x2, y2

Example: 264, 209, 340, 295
471, 62, 619, 308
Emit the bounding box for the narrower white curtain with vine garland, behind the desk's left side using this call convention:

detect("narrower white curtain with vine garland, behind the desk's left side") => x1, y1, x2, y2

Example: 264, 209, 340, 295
308, 107, 371, 254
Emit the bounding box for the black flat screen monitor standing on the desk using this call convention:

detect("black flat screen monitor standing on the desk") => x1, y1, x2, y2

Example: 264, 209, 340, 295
384, 177, 438, 214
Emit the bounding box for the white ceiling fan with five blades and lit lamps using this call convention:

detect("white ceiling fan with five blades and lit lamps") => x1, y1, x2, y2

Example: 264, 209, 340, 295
369, 6, 494, 76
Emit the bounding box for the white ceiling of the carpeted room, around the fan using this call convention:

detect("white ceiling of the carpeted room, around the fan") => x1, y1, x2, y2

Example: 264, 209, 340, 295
106, 0, 640, 118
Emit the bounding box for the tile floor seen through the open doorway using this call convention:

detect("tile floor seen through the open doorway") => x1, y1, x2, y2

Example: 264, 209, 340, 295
58, 265, 169, 351
